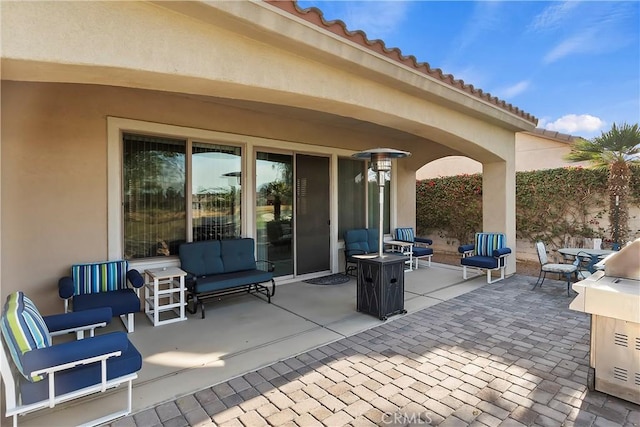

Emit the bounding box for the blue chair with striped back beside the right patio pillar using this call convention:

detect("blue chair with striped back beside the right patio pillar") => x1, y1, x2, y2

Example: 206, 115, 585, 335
458, 233, 511, 283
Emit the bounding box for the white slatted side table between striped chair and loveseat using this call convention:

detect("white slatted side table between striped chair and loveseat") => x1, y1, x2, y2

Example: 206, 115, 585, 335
144, 267, 187, 326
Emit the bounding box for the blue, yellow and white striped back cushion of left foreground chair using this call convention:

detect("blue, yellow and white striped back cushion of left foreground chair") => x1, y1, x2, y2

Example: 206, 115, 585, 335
0, 291, 51, 382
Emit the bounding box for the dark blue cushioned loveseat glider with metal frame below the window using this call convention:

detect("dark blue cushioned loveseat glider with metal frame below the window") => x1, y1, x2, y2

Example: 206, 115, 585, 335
178, 238, 276, 319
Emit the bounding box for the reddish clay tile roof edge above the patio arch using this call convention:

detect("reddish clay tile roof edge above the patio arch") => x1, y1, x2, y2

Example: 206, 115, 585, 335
264, 0, 538, 124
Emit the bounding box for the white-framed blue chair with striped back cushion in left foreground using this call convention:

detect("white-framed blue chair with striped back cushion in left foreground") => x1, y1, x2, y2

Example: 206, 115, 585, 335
0, 292, 142, 427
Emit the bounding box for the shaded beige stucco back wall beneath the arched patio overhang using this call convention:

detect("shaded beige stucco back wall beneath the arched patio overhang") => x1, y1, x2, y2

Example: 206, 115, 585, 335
1, 81, 432, 312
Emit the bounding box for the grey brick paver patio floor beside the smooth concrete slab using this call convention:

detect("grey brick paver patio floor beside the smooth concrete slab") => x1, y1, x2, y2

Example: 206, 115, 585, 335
111, 275, 640, 427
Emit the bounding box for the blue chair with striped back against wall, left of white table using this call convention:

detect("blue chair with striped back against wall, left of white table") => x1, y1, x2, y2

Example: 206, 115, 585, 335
58, 260, 144, 332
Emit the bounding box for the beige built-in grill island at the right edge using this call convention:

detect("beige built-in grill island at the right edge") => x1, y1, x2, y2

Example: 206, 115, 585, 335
569, 239, 640, 404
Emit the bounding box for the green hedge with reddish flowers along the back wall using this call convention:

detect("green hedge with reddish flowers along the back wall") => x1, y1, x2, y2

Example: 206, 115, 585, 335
416, 167, 640, 249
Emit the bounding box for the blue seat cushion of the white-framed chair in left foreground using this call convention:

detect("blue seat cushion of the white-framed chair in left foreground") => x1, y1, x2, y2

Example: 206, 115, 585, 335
20, 332, 142, 404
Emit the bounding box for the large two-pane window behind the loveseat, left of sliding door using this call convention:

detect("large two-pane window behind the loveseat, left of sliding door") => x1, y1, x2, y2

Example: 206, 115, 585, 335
122, 133, 241, 259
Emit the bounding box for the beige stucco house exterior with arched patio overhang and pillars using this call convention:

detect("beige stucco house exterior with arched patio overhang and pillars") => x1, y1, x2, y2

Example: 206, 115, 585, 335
0, 1, 533, 313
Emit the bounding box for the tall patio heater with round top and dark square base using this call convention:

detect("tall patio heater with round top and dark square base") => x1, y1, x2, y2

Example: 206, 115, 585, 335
353, 148, 411, 320
